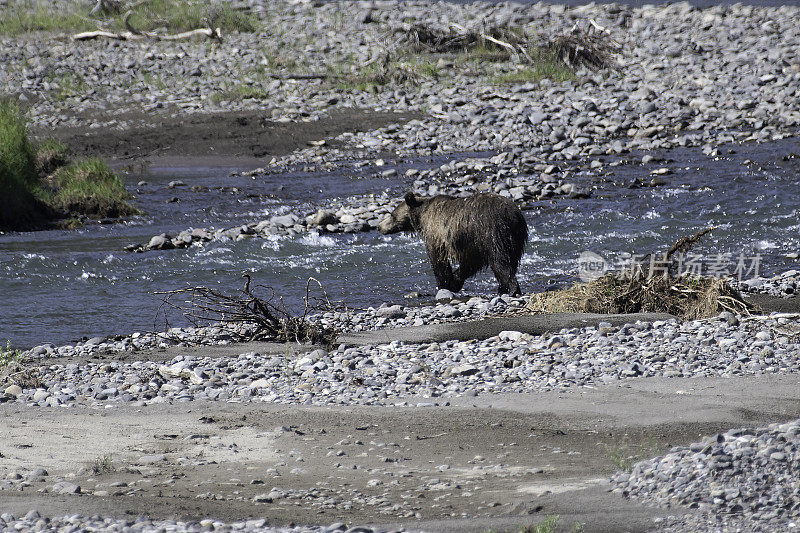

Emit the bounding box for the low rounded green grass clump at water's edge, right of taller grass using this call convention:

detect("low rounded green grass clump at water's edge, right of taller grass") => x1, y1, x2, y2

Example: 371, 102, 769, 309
45, 159, 138, 218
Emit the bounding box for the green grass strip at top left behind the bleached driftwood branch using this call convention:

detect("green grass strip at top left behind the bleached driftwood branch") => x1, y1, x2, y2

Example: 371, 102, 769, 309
0, 0, 262, 36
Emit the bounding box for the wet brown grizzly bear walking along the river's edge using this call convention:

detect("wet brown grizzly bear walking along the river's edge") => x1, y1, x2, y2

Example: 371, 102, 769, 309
378, 193, 528, 296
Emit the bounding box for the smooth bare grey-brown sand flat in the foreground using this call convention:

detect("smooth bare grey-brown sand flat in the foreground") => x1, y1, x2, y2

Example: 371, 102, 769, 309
0, 376, 800, 531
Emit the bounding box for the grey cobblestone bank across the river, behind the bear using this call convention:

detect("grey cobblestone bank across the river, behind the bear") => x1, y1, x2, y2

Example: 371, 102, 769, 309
6, 2, 800, 254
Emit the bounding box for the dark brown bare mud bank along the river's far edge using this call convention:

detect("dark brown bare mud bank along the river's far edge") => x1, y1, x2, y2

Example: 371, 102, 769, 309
40, 108, 417, 167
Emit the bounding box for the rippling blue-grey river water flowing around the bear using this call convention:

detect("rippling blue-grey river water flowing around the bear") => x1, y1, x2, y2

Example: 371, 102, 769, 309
0, 139, 800, 347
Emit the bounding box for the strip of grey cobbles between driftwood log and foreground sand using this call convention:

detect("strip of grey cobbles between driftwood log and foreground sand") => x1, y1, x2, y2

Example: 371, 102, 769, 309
2, 304, 800, 407
